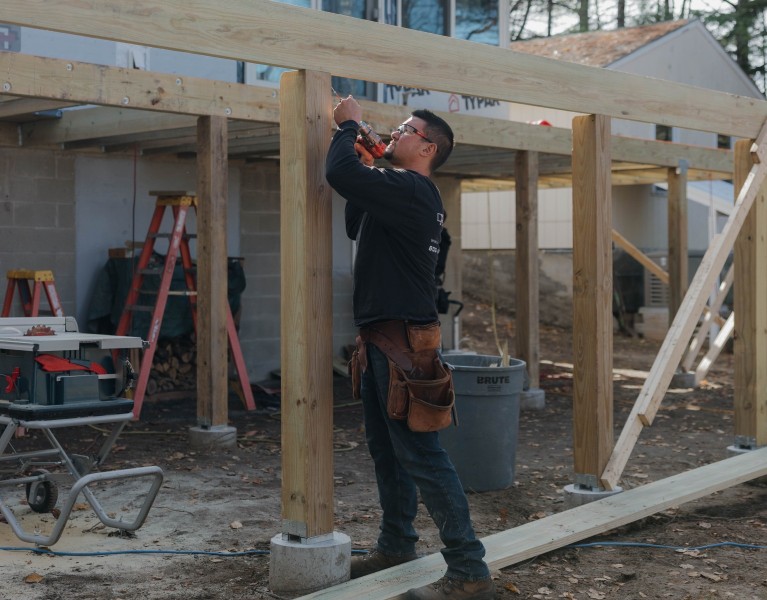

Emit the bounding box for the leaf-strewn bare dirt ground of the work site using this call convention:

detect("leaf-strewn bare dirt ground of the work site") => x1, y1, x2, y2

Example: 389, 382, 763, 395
0, 301, 767, 600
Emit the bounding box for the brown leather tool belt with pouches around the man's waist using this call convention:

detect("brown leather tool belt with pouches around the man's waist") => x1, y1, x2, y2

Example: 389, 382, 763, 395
349, 321, 458, 432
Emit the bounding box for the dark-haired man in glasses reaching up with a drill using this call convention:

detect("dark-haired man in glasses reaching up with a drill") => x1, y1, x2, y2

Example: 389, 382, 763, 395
326, 96, 495, 600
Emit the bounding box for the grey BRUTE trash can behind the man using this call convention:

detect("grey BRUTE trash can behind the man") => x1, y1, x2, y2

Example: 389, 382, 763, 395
439, 354, 525, 492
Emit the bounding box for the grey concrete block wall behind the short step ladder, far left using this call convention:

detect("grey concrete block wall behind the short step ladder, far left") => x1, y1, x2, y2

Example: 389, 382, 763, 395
0, 148, 76, 316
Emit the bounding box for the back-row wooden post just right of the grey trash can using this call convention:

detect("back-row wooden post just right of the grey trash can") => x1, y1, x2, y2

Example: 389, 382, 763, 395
514, 150, 540, 389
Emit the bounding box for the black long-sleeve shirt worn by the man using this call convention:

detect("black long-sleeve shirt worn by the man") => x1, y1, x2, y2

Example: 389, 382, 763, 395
326, 121, 445, 327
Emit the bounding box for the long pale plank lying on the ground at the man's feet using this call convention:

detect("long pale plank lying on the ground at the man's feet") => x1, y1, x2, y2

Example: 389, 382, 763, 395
300, 448, 767, 600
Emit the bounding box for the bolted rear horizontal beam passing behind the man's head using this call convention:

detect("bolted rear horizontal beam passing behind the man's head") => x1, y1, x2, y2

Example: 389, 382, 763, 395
0, 52, 733, 174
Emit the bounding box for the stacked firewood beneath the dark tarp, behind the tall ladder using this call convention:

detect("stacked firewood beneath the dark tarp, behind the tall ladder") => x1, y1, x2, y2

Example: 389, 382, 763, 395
146, 335, 197, 396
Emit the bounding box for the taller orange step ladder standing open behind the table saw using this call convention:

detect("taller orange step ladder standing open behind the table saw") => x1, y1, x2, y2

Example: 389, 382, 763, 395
115, 192, 256, 418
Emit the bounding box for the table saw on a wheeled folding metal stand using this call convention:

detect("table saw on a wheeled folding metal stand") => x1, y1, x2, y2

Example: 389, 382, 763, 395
0, 317, 163, 546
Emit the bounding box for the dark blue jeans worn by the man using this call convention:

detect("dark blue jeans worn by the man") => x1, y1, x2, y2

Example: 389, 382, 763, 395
361, 343, 490, 581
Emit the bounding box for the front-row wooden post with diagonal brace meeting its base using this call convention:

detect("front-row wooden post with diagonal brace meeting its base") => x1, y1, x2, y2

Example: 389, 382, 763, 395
573, 115, 613, 489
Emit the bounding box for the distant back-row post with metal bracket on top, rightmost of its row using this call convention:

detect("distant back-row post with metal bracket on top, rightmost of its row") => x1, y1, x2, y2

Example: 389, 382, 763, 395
668, 160, 688, 325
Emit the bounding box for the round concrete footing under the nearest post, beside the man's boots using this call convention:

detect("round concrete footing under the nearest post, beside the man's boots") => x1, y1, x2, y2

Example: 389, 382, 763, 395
269, 531, 352, 597
